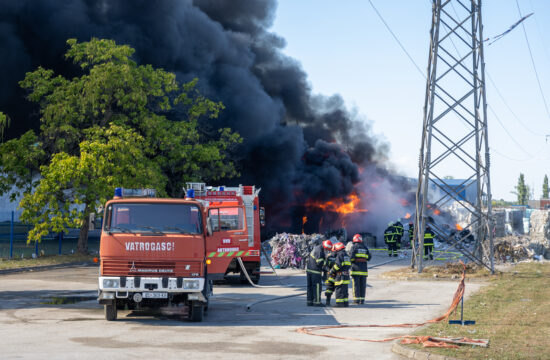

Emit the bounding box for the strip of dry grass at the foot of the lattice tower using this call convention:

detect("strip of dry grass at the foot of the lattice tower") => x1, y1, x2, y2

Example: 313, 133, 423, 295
382, 262, 495, 280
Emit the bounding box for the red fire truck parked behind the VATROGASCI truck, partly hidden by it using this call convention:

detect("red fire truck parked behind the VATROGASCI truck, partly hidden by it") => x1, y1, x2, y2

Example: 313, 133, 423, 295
187, 183, 265, 283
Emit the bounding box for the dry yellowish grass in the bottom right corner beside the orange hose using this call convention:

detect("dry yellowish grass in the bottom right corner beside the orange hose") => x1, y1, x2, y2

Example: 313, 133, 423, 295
408, 263, 550, 359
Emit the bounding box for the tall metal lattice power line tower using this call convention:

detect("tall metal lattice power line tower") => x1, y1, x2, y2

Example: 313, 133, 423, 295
411, 0, 494, 272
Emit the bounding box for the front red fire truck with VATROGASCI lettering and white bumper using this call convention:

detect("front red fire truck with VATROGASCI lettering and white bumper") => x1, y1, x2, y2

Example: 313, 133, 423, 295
98, 188, 212, 321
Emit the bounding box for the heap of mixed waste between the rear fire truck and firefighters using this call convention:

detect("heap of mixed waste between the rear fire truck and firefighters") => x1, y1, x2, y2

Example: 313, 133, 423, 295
269, 233, 325, 269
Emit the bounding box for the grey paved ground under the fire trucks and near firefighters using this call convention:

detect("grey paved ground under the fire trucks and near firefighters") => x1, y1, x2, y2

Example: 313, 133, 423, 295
0, 255, 480, 360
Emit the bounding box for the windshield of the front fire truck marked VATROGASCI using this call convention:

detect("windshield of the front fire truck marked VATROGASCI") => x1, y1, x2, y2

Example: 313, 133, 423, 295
104, 203, 202, 235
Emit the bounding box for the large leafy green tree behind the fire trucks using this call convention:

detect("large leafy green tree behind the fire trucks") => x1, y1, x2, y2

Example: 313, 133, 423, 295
0, 39, 241, 252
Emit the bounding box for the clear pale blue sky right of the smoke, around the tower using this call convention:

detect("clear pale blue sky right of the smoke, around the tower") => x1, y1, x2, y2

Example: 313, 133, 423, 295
272, 0, 550, 200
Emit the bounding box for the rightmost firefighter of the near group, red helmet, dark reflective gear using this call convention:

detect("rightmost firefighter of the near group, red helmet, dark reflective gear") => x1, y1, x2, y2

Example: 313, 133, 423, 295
349, 234, 370, 304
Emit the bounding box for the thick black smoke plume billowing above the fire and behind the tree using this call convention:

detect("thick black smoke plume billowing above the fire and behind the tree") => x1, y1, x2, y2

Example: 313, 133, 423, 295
0, 0, 406, 236
